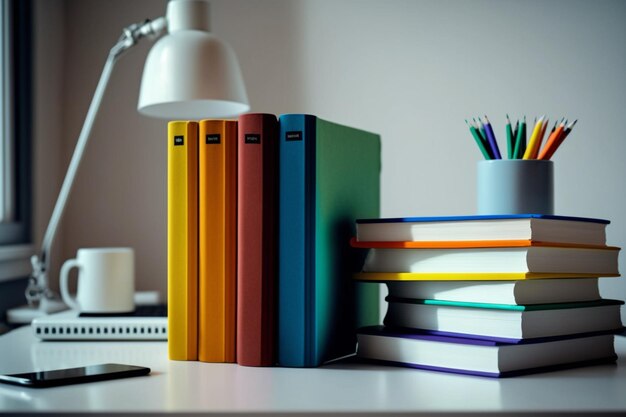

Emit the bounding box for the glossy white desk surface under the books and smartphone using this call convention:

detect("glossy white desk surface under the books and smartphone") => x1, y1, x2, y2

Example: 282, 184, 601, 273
0, 326, 626, 415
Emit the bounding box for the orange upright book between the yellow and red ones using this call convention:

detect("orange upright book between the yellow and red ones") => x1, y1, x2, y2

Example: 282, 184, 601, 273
198, 120, 237, 362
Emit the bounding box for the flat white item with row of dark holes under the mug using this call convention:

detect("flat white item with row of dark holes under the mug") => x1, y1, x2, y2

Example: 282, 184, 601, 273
31, 304, 167, 340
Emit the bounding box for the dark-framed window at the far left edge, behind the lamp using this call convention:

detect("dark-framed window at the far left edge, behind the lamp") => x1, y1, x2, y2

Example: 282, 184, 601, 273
0, 0, 32, 281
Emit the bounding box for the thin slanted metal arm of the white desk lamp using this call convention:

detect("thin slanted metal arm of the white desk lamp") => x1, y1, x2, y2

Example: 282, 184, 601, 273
26, 17, 167, 305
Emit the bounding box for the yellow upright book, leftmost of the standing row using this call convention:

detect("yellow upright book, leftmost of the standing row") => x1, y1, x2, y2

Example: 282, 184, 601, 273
167, 121, 198, 360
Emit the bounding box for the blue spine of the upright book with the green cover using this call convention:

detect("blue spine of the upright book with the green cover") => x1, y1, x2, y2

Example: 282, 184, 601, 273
278, 114, 315, 367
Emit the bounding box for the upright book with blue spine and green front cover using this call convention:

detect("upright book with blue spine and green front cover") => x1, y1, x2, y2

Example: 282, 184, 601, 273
278, 114, 381, 367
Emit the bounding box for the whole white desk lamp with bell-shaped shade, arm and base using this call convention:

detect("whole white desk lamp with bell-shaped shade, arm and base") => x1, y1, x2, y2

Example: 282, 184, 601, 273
7, 0, 250, 323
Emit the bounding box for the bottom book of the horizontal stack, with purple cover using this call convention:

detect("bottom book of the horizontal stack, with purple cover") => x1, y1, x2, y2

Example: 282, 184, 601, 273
357, 326, 617, 377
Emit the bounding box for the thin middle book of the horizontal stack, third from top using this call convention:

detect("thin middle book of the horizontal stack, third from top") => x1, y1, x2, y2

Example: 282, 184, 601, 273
387, 278, 600, 305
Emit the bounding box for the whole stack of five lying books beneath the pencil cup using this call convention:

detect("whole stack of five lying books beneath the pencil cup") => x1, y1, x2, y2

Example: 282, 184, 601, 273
352, 214, 623, 377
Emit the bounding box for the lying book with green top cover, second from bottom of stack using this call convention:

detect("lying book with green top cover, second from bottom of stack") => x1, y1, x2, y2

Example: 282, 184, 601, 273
384, 297, 623, 341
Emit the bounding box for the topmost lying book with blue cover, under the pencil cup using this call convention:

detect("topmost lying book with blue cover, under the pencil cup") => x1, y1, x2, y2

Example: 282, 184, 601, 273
356, 214, 609, 246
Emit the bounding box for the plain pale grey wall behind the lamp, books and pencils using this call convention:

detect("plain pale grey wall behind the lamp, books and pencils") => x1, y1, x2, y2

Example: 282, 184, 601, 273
35, 0, 626, 308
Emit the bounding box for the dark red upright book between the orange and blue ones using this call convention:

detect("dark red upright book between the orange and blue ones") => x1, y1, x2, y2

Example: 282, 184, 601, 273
237, 114, 278, 366
